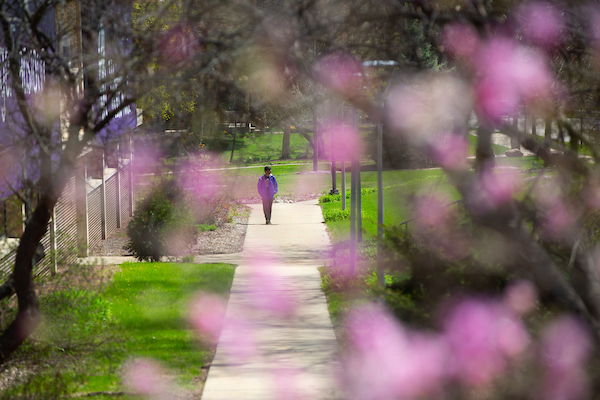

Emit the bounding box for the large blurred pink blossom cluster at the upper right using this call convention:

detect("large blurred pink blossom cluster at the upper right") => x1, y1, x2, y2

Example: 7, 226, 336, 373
443, 1, 565, 126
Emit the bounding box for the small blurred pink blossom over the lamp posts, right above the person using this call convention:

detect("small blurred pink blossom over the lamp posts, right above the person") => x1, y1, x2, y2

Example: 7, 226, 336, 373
322, 121, 362, 160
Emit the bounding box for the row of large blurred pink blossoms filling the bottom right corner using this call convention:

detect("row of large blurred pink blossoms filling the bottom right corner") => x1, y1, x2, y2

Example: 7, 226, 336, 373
342, 281, 591, 400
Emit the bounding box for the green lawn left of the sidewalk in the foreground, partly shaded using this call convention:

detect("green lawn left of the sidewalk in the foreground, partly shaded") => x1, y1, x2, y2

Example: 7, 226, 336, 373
0, 263, 234, 399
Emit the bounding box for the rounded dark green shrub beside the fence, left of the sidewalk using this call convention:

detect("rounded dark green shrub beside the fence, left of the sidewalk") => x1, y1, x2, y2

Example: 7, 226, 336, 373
126, 179, 197, 261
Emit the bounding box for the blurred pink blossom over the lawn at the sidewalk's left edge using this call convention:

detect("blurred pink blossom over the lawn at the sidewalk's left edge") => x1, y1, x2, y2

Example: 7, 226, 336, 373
188, 294, 227, 340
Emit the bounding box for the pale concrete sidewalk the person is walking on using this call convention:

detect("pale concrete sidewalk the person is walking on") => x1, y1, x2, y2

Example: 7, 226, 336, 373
202, 201, 342, 400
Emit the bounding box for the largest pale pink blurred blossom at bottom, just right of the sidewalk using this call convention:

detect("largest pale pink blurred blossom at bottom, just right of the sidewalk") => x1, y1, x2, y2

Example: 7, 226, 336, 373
343, 306, 446, 400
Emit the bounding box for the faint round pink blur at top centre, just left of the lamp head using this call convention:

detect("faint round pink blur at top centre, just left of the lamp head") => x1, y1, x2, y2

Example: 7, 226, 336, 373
315, 53, 364, 93
